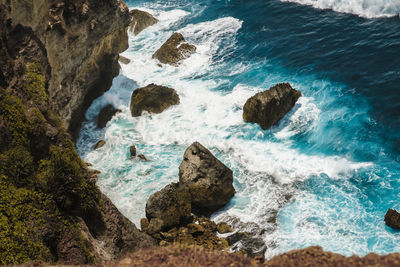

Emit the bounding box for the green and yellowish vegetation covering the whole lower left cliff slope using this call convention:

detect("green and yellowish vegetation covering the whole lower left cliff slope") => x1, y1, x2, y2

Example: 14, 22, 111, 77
0, 60, 101, 264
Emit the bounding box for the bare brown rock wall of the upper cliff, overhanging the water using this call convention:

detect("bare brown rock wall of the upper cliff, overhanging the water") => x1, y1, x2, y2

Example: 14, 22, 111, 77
0, 0, 130, 137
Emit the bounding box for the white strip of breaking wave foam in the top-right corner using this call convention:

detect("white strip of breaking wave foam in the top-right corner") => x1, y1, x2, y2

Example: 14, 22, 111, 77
281, 0, 400, 18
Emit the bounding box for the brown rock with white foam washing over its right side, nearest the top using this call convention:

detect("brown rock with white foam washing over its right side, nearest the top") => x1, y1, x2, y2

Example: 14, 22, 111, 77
153, 32, 196, 66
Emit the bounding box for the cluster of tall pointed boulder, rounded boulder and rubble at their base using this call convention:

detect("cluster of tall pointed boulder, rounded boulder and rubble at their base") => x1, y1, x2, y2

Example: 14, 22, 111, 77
140, 143, 234, 250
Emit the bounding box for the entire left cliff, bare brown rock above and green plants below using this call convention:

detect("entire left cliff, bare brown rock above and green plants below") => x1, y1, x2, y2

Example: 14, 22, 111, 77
0, 0, 154, 264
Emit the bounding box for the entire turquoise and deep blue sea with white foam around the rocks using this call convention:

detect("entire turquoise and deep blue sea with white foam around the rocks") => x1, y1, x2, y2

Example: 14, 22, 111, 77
77, 0, 400, 257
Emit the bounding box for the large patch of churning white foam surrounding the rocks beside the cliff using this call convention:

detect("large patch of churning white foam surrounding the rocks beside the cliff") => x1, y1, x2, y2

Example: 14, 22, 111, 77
78, 3, 378, 258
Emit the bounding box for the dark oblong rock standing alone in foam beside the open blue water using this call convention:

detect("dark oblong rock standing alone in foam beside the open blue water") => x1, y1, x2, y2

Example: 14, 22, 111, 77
243, 83, 301, 130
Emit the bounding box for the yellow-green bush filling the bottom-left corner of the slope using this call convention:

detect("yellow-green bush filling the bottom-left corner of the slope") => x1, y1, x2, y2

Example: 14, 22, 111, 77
0, 175, 53, 264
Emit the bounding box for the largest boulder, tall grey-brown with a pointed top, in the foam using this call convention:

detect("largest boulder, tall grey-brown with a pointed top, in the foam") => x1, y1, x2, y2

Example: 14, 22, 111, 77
179, 142, 235, 214
